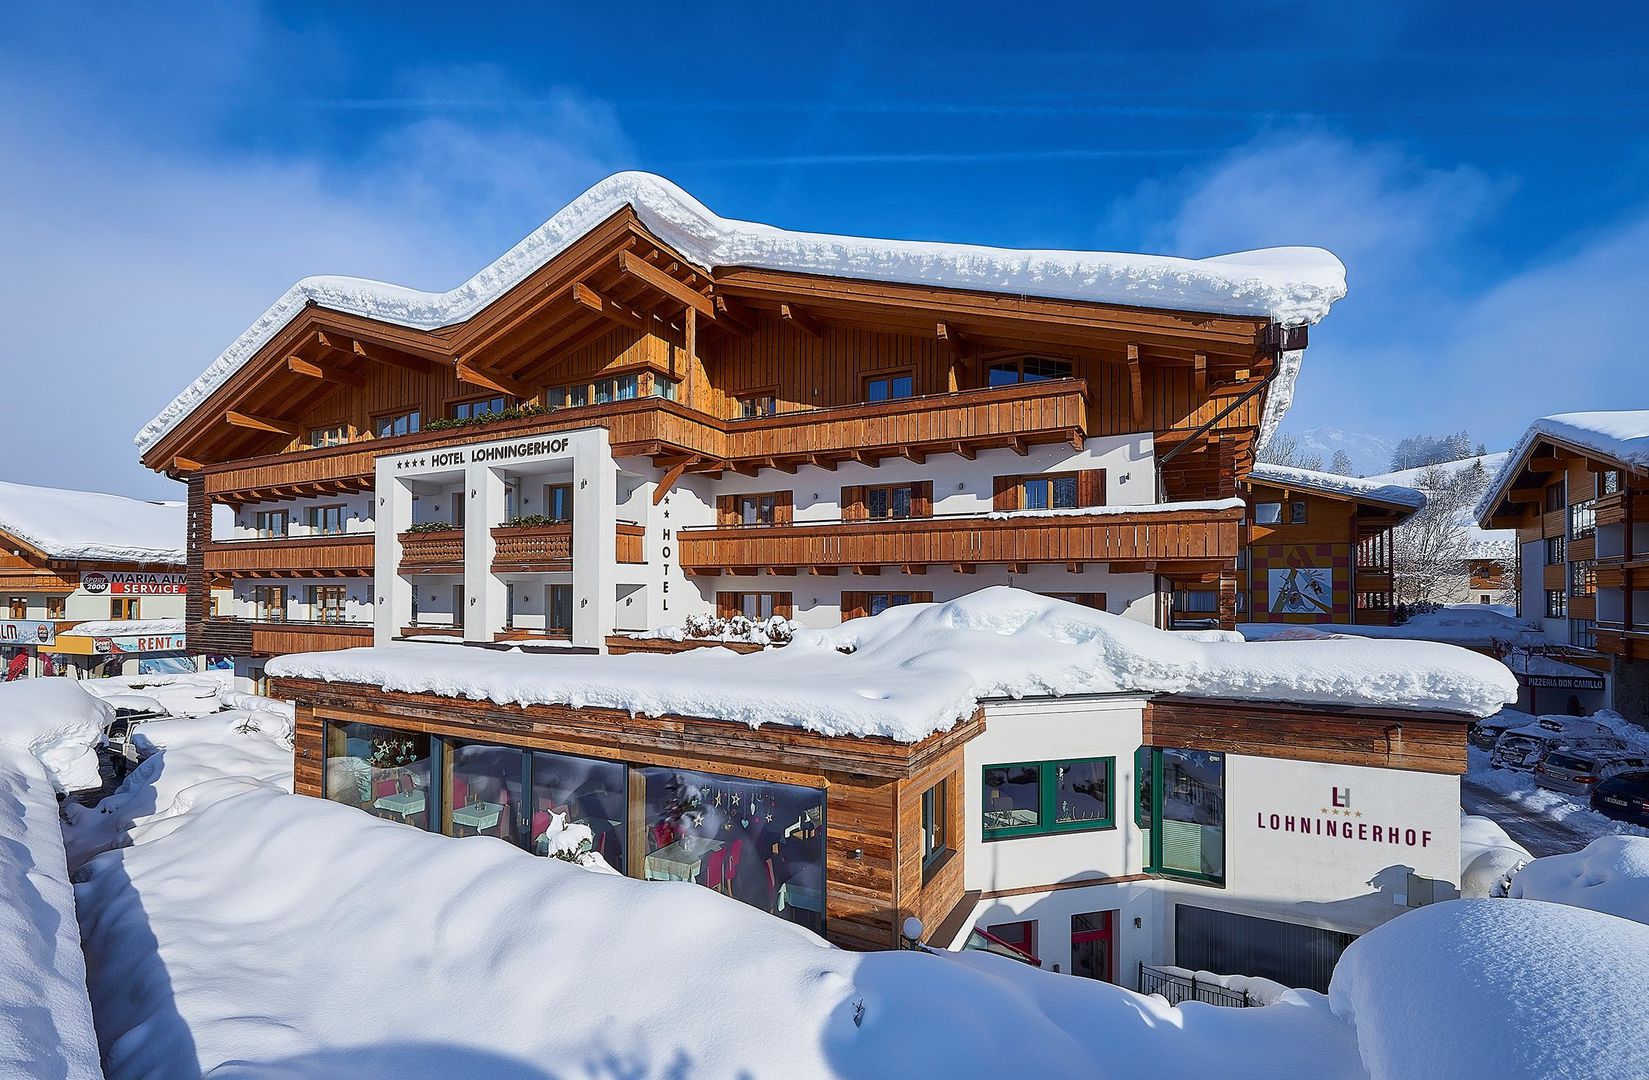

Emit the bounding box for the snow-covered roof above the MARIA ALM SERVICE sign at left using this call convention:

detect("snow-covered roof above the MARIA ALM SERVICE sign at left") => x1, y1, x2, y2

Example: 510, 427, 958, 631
0, 481, 188, 566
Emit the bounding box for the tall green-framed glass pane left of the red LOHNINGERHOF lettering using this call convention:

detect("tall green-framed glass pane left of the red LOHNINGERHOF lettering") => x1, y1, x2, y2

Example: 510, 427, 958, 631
1151, 749, 1225, 884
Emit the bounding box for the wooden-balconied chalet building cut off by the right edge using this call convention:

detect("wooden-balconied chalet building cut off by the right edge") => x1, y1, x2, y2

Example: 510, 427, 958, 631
1478, 412, 1649, 724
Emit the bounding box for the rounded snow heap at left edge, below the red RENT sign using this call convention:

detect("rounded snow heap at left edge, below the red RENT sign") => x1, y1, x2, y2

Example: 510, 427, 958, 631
0, 679, 114, 791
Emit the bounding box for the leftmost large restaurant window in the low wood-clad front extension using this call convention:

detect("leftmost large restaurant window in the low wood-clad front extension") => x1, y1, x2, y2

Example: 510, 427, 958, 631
319, 722, 435, 829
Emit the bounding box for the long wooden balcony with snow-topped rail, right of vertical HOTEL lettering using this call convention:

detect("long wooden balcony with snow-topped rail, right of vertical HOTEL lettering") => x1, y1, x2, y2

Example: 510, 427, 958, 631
678, 509, 1242, 575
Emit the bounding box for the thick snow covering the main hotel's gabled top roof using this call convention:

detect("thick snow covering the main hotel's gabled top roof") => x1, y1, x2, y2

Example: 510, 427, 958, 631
135, 173, 1346, 452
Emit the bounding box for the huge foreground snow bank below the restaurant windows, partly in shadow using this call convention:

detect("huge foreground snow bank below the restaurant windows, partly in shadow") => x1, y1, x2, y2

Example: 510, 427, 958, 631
76, 778, 1364, 1080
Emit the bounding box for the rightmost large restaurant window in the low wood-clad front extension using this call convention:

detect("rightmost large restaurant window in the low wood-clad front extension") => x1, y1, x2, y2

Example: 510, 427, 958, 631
638, 768, 825, 930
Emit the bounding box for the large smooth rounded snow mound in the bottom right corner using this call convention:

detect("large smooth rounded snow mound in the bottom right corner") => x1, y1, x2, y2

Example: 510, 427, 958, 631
1325, 896, 1649, 1080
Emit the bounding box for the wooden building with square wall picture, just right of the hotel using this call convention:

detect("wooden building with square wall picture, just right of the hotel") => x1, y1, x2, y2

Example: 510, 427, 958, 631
1238, 463, 1426, 627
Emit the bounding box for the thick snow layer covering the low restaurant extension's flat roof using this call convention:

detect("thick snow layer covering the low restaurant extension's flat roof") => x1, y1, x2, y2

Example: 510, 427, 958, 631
267, 587, 1517, 742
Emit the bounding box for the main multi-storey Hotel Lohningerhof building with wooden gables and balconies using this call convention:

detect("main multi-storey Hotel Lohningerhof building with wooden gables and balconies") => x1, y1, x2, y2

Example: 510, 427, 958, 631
128, 178, 1342, 689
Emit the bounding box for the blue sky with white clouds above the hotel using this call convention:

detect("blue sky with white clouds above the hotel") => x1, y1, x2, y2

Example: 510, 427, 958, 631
0, 2, 1649, 496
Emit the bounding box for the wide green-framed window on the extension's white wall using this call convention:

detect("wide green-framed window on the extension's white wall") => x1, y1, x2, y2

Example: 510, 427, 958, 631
983, 757, 1116, 839
